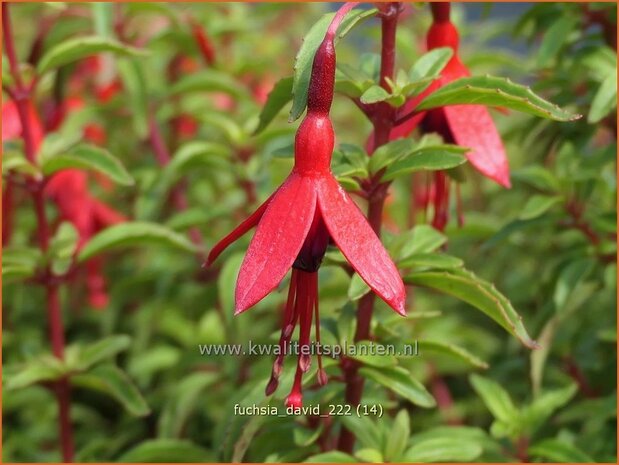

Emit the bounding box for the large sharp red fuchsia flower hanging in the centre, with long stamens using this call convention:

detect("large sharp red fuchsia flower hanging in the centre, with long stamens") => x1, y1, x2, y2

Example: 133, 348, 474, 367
207, 3, 406, 407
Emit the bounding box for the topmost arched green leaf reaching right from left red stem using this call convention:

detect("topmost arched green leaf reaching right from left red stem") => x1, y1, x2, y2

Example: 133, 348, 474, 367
37, 36, 145, 74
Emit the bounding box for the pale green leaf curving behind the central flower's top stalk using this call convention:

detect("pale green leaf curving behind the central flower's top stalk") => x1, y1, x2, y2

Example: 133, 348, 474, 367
288, 8, 377, 122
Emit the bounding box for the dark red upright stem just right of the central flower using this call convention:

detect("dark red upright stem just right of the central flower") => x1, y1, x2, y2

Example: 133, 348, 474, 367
338, 2, 400, 453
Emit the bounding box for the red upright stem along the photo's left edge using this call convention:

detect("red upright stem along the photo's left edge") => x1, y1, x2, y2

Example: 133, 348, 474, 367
2, 3, 74, 462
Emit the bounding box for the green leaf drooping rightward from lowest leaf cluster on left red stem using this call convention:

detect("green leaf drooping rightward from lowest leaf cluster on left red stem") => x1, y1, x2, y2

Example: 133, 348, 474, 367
71, 364, 150, 417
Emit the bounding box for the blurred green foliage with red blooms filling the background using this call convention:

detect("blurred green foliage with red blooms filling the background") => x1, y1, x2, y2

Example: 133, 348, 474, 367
2, 3, 617, 462
